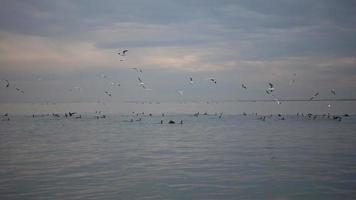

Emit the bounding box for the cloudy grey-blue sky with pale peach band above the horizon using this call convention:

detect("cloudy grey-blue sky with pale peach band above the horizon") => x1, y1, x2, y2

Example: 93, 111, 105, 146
0, 0, 356, 113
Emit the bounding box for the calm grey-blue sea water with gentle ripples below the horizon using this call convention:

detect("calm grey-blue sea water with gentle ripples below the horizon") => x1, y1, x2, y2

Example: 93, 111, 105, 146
0, 114, 356, 200
